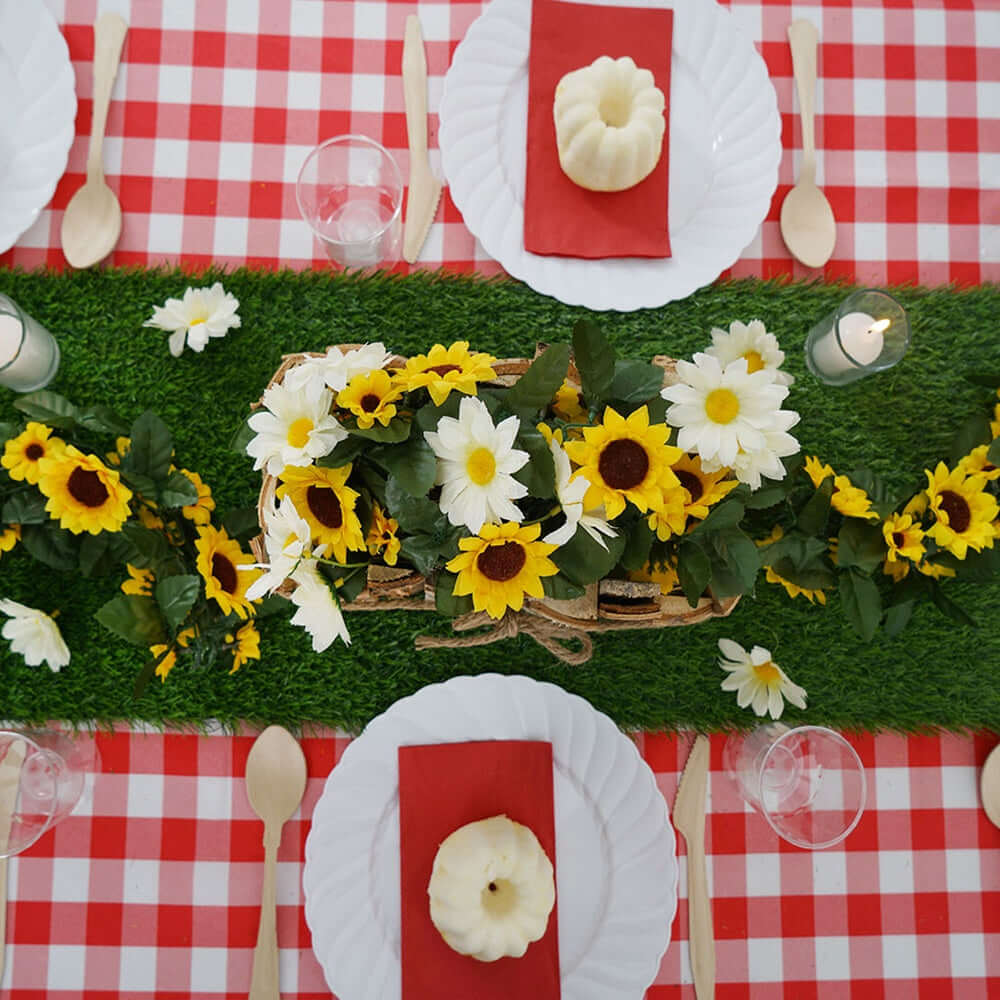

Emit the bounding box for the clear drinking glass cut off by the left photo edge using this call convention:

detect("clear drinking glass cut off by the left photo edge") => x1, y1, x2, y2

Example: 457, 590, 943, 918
0, 729, 98, 858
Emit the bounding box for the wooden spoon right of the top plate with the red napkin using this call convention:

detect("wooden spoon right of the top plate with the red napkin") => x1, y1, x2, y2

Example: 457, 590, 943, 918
781, 21, 837, 267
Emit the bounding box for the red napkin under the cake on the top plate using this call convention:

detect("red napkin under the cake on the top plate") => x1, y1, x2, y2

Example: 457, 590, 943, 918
524, 0, 674, 258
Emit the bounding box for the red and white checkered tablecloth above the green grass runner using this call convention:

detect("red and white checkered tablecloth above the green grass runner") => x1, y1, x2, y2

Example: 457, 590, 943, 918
0, 0, 1000, 284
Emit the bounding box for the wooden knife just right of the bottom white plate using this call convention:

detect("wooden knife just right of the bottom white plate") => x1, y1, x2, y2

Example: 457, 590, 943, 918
674, 736, 715, 1000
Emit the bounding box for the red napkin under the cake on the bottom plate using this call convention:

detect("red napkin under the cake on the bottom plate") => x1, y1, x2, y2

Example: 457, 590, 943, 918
399, 740, 560, 1000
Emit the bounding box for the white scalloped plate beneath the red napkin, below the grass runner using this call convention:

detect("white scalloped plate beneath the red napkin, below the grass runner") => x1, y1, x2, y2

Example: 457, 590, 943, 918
302, 674, 677, 1000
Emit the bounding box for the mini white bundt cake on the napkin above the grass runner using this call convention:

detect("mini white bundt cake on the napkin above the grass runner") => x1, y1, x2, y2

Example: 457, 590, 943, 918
552, 56, 666, 191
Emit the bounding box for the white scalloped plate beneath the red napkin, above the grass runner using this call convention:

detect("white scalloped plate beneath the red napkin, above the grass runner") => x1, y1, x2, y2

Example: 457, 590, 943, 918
438, 0, 781, 312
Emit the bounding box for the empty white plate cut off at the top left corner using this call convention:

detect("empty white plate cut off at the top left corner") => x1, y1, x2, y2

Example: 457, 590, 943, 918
0, 0, 76, 253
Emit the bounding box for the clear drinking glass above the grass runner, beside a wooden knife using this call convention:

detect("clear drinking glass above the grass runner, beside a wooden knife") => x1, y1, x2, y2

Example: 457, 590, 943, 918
295, 135, 403, 268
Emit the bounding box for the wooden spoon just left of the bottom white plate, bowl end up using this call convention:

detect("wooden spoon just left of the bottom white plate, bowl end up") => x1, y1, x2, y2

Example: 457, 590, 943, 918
246, 726, 306, 1000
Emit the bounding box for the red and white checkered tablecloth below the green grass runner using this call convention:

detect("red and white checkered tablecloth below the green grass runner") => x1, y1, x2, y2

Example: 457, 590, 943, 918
2, 729, 1000, 1000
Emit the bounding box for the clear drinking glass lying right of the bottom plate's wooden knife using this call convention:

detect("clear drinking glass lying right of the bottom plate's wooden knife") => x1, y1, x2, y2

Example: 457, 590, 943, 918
723, 722, 867, 849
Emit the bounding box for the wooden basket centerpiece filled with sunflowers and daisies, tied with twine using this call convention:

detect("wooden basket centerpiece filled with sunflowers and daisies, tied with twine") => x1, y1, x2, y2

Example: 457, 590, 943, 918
248, 332, 746, 663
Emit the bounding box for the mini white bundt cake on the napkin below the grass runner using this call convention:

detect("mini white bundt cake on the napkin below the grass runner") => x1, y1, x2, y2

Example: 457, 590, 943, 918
427, 816, 556, 962
